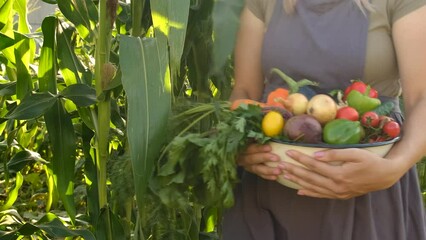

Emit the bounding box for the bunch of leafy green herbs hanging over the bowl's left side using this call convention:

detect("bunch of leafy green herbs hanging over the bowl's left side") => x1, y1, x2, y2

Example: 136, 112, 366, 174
151, 102, 269, 209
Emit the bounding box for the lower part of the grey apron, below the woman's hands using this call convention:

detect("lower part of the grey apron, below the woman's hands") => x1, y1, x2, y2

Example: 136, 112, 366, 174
222, 167, 426, 240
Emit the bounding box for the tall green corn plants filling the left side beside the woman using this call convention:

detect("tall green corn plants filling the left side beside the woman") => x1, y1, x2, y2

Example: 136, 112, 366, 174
0, 0, 426, 240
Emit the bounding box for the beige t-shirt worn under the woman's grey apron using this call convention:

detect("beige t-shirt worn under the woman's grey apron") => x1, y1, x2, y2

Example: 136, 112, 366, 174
246, 0, 426, 97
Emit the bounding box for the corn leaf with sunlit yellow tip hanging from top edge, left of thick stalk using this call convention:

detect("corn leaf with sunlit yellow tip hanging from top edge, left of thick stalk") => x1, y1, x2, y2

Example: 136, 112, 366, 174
58, 0, 98, 42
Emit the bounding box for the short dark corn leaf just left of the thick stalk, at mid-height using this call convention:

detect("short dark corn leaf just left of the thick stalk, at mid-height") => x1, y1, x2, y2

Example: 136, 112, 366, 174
59, 84, 97, 107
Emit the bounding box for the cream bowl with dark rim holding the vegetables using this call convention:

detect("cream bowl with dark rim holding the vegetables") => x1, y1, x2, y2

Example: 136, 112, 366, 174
267, 137, 400, 189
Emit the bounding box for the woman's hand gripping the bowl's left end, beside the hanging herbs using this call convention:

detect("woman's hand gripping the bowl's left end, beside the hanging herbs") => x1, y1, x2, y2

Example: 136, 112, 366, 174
237, 144, 282, 180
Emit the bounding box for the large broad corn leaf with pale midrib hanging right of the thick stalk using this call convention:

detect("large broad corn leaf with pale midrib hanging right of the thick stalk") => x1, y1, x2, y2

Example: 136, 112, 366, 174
120, 36, 171, 220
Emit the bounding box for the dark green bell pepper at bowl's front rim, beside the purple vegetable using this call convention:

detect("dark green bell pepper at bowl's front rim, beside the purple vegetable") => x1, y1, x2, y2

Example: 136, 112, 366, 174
323, 119, 363, 144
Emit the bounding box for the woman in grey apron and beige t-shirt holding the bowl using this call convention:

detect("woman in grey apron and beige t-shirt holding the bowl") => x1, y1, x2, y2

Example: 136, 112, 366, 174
223, 0, 426, 240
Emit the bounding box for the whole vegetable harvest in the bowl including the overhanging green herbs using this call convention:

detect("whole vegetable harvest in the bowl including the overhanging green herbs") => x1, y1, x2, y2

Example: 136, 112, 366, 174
155, 69, 400, 209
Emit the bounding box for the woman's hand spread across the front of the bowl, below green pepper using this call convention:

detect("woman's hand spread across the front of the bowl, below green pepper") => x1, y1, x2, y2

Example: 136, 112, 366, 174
282, 148, 404, 199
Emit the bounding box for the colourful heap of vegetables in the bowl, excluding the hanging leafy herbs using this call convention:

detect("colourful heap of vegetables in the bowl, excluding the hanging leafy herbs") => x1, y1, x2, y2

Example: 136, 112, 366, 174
243, 69, 401, 144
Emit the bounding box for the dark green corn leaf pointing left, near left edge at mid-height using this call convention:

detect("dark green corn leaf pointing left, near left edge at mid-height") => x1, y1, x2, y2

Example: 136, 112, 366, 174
4, 93, 56, 120
